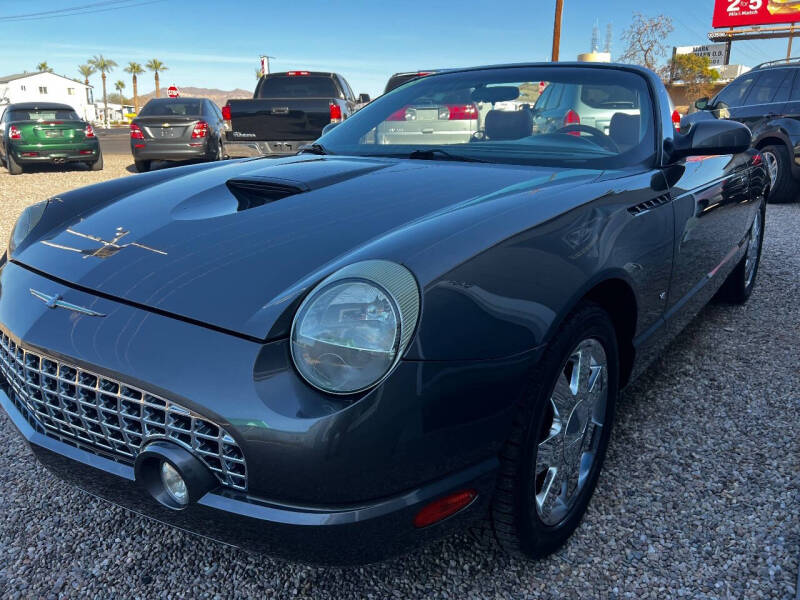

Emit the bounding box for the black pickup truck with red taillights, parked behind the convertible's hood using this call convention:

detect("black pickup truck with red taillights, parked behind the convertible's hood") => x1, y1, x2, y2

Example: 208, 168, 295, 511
222, 71, 369, 158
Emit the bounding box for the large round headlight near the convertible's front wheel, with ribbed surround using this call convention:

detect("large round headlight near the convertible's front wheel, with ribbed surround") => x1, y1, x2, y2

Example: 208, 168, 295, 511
291, 260, 419, 394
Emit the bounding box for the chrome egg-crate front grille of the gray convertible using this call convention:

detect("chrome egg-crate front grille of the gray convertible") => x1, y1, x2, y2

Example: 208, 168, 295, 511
0, 332, 247, 490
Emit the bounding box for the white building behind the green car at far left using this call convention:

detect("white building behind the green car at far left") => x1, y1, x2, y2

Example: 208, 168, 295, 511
0, 71, 95, 121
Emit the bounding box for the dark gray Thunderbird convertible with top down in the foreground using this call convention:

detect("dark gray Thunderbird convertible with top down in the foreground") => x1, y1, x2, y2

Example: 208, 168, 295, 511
0, 64, 768, 563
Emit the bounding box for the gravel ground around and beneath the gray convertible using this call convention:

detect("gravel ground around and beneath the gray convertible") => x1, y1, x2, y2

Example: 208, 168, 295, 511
0, 157, 800, 600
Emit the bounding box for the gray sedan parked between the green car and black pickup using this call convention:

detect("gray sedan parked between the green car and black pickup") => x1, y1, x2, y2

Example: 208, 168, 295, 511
131, 98, 224, 173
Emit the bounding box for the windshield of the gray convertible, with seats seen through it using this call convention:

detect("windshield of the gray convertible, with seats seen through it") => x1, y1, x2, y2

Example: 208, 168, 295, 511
319, 66, 656, 169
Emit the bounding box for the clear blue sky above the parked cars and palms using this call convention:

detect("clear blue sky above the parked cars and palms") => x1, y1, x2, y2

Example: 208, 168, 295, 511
0, 0, 800, 95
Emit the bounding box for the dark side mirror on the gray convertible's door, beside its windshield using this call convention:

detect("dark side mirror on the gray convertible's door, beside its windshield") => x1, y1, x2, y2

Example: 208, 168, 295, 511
670, 120, 752, 160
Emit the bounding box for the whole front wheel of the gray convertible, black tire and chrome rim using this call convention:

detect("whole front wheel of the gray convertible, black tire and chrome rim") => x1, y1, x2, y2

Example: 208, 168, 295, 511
490, 303, 619, 558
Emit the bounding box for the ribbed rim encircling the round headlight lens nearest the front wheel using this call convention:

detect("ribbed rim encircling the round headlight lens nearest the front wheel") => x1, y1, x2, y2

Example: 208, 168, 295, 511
289, 260, 420, 396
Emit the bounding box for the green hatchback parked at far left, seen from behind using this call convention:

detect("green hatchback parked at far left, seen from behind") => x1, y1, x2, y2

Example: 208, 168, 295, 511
0, 102, 103, 175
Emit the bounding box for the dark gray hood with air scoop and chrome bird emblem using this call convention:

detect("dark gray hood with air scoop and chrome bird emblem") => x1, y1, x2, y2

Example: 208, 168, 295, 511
13, 155, 598, 339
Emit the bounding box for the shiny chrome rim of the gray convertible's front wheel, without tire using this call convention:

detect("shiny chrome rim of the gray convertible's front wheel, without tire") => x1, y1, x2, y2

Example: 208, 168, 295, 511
533, 338, 608, 526
